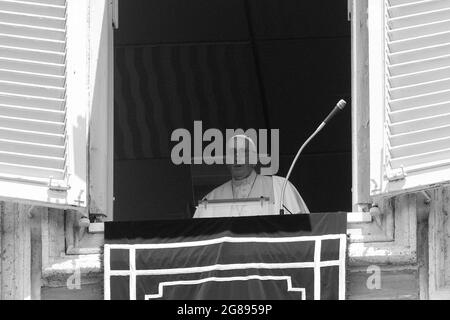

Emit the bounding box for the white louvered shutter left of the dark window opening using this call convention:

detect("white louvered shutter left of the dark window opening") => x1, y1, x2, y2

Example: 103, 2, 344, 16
0, 0, 88, 207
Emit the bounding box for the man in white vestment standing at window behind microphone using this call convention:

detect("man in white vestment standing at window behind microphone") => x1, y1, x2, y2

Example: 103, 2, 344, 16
194, 135, 309, 218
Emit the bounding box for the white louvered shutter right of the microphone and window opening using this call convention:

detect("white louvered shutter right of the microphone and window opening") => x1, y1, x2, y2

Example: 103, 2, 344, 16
369, 0, 450, 194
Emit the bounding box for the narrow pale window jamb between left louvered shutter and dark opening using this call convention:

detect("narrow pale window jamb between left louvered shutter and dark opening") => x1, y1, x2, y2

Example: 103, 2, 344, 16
88, 0, 119, 221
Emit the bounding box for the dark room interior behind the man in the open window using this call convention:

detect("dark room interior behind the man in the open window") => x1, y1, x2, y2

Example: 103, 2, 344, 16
114, 0, 351, 220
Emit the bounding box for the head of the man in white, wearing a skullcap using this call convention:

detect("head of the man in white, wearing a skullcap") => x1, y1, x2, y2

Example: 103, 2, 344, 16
227, 134, 257, 180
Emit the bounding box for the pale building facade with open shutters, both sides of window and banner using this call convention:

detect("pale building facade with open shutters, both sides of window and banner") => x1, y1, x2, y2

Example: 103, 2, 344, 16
0, 0, 450, 299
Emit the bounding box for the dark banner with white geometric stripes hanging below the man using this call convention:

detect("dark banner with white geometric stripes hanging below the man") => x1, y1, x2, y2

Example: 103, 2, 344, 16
104, 213, 347, 300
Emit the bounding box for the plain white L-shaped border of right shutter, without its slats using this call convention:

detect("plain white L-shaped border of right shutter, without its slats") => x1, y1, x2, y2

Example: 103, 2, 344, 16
368, 0, 450, 199
